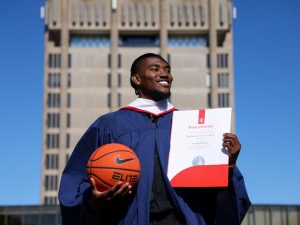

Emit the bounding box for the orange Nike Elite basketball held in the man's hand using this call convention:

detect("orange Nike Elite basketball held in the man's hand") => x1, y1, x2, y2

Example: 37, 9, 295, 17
87, 143, 141, 191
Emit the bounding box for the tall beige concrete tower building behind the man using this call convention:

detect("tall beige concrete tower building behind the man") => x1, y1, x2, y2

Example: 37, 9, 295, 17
40, 0, 234, 205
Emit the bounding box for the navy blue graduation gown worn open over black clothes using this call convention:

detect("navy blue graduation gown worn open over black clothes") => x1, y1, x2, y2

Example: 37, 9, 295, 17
59, 109, 250, 225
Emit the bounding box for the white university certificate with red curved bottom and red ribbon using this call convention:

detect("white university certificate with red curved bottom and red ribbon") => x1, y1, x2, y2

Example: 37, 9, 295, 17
168, 108, 231, 187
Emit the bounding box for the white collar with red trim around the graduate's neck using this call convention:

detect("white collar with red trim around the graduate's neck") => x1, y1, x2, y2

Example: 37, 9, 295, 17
121, 98, 176, 116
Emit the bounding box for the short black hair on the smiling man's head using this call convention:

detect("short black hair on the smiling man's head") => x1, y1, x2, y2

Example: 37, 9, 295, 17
130, 53, 169, 95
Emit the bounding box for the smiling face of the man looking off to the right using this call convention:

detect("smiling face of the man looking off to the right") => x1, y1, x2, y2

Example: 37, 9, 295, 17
132, 57, 173, 101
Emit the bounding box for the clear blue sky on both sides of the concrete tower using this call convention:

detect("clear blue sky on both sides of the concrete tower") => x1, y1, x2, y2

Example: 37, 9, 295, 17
0, 0, 300, 205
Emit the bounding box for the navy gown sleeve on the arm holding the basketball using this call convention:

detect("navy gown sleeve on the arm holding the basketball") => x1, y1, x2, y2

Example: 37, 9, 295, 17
58, 118, 110, 225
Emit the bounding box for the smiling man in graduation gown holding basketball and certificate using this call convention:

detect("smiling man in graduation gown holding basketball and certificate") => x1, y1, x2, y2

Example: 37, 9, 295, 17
59, 53, 250, 225
